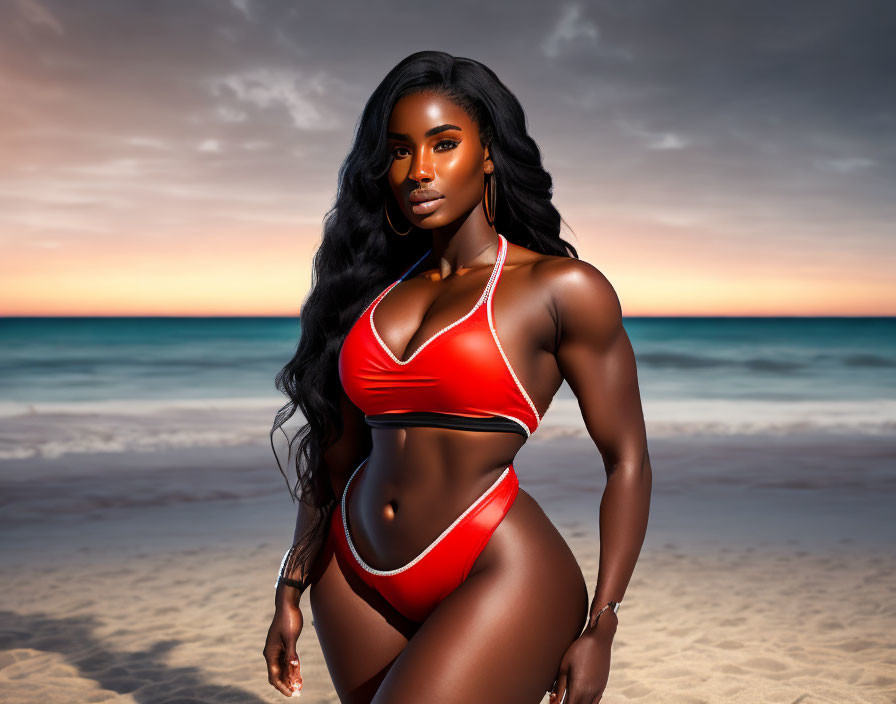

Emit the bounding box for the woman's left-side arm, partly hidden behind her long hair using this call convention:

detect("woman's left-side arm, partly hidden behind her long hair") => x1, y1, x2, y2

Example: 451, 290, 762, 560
275, 384, 369, 606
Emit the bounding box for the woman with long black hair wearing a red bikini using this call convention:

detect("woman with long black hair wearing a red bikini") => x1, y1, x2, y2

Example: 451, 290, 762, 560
264, 51, 651, 704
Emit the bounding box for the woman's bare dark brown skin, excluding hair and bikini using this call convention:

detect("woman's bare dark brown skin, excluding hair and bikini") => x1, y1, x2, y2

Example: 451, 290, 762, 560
264, 93, 651, 704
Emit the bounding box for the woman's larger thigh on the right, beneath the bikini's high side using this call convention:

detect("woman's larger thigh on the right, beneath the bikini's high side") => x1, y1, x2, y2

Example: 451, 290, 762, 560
373, 489, 588, 704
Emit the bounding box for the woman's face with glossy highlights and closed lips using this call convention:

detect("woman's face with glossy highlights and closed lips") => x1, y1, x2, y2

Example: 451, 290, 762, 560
387, 92, 494, 229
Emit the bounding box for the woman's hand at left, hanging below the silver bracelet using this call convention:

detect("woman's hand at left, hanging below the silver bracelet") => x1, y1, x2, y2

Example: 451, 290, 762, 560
262, 585, 304, 697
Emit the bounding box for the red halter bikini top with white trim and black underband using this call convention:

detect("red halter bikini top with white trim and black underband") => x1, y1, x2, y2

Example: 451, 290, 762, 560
339, 234, 541, 438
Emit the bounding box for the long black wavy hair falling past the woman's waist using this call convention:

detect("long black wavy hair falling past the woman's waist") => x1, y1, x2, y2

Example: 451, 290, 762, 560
271, 51, 578, 573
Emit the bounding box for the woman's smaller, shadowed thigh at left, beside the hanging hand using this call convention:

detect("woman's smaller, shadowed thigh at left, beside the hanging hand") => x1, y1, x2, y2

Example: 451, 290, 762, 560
309, 540, 417, 704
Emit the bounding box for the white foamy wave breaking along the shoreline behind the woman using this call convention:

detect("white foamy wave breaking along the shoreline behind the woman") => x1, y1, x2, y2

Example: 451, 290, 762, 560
0, 396, 896, 460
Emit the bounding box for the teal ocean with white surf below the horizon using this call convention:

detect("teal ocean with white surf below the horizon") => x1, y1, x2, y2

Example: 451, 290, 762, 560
0, 317, 896, 459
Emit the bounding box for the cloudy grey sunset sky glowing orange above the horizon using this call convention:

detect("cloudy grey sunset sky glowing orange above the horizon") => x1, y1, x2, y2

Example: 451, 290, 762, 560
0, 0, 896, 316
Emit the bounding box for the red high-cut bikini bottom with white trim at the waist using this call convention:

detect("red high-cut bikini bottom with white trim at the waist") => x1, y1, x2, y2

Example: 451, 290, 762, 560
316, 459, 519, 623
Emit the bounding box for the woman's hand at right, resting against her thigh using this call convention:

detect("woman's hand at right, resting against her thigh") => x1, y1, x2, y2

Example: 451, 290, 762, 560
550, 610, 618, 704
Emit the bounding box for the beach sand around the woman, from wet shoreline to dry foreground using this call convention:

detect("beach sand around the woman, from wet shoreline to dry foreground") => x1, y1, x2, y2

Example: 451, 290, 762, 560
0, 428, 896, 704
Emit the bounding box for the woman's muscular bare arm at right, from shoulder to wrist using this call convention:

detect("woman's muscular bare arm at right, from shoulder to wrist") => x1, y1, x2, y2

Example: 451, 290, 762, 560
551, 259, 652, 638
